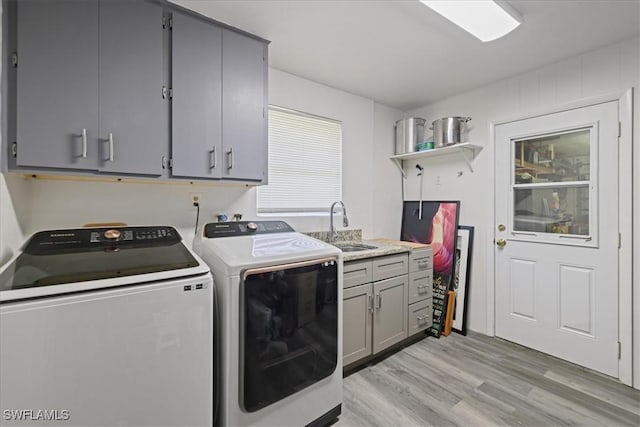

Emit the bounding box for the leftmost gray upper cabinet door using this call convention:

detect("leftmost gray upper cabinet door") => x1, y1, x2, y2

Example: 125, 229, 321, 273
17, 0, 98, 170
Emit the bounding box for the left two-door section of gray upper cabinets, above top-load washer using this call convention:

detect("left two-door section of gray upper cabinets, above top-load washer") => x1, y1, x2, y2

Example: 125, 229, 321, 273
16, 0, 167, 176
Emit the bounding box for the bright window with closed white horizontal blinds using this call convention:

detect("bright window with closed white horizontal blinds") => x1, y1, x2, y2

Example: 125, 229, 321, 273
258, 106, 342, 213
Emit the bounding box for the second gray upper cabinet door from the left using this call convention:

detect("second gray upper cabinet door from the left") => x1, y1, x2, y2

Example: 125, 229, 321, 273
98, 0, 168, 175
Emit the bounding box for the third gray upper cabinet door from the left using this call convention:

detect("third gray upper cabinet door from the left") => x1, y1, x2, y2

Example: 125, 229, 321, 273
171, 13, 224, 178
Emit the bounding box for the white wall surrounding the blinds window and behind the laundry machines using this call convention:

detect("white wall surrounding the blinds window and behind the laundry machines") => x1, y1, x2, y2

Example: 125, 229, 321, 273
0, 69, 401, 254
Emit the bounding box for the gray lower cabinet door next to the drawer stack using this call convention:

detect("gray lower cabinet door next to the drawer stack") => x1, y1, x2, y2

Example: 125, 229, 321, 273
373, 274, 408, 353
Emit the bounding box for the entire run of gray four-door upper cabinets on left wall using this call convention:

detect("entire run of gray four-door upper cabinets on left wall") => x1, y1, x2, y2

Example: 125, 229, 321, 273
9, 0, 268, 184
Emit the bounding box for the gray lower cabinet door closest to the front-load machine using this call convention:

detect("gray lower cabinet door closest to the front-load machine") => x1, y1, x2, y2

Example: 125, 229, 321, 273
342, 283, 373, 366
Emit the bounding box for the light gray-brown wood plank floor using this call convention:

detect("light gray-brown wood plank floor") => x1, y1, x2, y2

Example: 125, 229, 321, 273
334, 332, 640, 427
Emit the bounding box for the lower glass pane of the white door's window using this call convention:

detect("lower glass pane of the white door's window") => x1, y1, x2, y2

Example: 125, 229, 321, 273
513, 184, 589, 236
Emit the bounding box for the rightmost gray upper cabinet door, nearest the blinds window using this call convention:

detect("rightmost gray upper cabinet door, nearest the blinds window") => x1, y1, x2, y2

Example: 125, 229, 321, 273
222, 30, 268, 181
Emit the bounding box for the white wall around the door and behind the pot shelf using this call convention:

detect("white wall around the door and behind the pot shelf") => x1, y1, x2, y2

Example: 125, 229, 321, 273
406, 38, 640, 384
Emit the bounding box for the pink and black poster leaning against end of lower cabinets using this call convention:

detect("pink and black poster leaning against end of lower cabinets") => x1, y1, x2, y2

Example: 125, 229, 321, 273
400, 200, 460, 337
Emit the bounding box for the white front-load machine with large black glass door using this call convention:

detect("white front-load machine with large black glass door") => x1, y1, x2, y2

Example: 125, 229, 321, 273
193, 221, 342, 426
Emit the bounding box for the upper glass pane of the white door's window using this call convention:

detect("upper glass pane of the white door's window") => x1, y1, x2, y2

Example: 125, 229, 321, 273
513, 128, 591, 184
